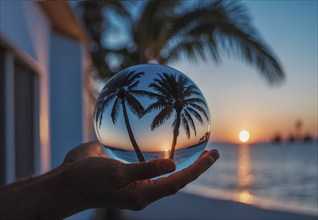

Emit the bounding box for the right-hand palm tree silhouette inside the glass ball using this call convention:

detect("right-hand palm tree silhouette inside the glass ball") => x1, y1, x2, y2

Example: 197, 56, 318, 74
145, 73, 209, 159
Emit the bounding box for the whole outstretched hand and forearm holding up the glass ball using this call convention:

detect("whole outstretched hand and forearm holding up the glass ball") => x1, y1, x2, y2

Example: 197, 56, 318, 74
0, 142, 219, 219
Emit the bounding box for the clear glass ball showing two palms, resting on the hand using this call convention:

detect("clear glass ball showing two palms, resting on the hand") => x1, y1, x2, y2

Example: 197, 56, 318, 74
94, 64, 211, 170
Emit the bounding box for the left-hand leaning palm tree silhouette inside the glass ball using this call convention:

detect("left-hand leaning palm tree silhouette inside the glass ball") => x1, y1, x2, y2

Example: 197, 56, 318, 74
95, 71, 147, 161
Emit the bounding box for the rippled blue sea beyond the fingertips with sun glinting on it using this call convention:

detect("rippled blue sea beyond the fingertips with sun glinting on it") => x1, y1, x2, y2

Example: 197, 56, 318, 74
184, 142, 318, 215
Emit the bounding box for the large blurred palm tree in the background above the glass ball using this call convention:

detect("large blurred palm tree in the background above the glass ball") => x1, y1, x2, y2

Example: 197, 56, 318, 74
79, 0, 285, 84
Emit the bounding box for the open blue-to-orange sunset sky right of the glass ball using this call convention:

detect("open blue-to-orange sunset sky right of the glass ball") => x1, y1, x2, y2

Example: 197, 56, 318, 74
171, 0, 318, 143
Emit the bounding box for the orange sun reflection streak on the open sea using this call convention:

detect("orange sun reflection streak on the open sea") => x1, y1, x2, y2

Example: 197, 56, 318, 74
236, 145, 254, 204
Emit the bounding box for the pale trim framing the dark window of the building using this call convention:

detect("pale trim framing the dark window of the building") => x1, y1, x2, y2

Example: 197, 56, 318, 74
0, 32, 50, 180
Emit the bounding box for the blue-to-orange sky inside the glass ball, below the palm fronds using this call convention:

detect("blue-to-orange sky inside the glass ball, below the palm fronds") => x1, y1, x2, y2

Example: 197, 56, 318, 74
100, 108, 209, 152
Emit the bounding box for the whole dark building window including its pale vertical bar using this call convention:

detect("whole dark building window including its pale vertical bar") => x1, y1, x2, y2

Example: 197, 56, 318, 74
0, 45, 39, 185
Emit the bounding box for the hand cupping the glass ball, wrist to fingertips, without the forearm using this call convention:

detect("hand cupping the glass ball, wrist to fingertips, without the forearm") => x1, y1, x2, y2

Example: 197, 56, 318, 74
61, 142, 219, 210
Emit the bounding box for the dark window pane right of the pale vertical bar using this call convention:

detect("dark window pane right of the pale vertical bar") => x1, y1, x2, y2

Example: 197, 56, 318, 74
14, 62, 36, 178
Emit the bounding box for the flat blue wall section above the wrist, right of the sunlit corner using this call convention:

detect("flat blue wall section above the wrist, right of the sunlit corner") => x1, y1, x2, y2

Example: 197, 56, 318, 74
50, 33, 84, 167
